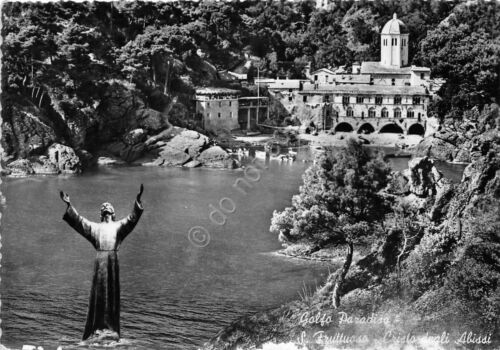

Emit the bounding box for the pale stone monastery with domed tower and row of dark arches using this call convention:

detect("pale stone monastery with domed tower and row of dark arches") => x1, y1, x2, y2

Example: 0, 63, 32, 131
268, 14, 433, 135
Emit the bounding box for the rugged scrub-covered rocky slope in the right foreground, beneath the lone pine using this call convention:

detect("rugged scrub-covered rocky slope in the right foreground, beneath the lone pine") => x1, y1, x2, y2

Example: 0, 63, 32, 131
203, 119, 500, 350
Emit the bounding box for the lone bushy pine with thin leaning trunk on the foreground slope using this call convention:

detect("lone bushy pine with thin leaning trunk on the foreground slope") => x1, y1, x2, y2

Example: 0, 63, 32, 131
271, 139, 390, 306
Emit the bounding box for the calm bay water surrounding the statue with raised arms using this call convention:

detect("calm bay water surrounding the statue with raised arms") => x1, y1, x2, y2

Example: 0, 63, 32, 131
1, 150, 463, 350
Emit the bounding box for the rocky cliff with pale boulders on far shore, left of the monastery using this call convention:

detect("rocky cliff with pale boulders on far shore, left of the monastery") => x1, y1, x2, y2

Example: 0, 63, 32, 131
2, 80, 236, 176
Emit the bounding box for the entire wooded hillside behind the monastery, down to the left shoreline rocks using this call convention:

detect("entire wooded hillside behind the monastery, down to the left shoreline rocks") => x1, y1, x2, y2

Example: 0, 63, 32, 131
2, 0, 500, 169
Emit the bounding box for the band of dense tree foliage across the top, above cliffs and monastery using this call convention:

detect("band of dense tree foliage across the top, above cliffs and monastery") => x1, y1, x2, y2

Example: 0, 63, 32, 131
2, 0, 500, 126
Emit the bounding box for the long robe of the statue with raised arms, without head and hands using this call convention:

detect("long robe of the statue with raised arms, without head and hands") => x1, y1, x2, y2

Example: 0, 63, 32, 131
63, 201, 143, 340
